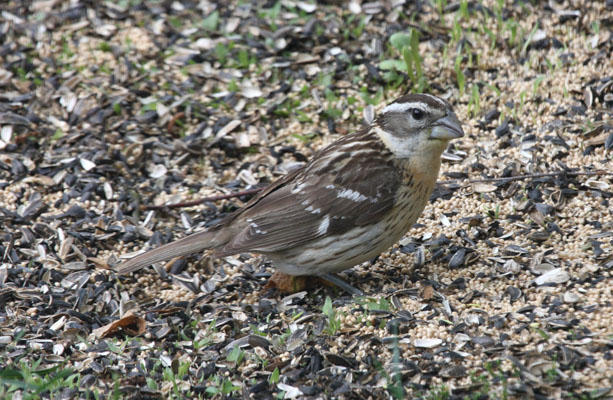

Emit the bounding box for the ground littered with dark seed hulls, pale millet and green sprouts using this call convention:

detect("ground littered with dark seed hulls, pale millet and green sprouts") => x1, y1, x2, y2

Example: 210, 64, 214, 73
0, 0, 613, 399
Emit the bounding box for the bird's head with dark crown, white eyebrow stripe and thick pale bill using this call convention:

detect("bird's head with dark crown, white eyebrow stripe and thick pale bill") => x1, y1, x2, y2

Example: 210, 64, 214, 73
374, 94, 464, 158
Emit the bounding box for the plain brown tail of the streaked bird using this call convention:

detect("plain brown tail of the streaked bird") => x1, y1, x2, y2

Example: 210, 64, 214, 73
115, 231, 219, 275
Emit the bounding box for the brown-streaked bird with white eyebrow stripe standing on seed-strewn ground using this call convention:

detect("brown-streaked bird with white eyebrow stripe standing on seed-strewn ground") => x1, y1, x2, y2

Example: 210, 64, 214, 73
115, 93, 464, 291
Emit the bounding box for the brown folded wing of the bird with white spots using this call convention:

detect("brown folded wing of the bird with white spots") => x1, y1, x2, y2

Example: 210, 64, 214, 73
217, 158, 401, 255
